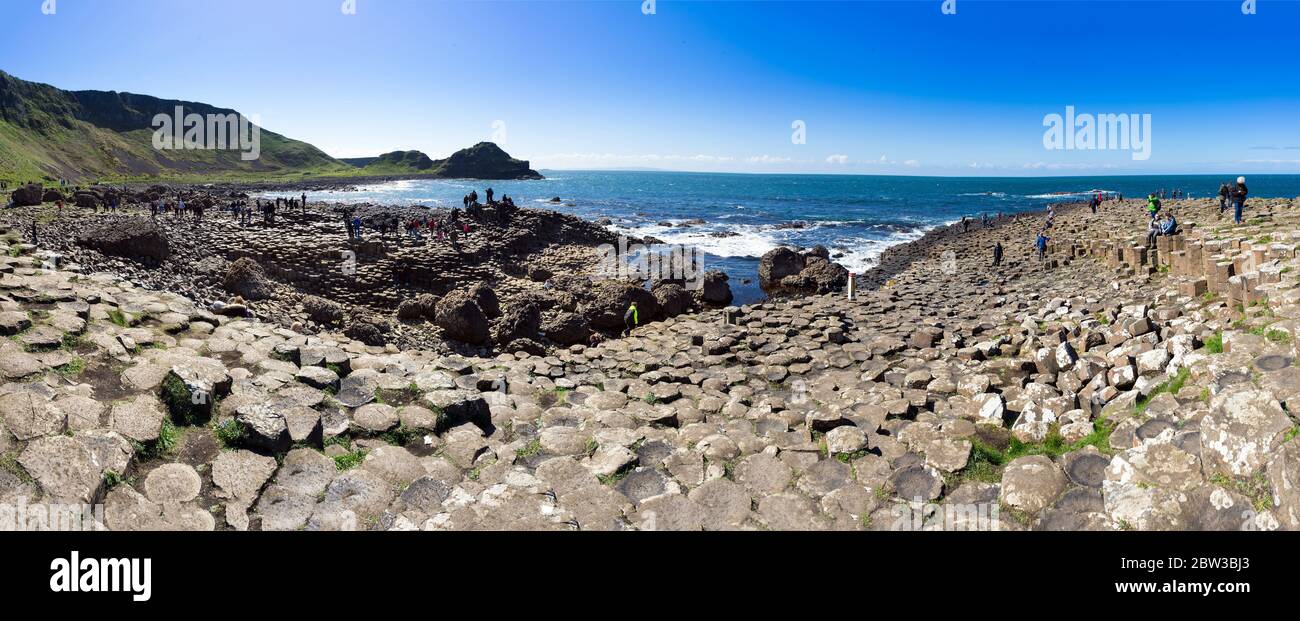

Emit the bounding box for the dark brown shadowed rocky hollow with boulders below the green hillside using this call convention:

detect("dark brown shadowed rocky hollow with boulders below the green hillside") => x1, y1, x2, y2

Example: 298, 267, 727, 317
5, 186, 759, 356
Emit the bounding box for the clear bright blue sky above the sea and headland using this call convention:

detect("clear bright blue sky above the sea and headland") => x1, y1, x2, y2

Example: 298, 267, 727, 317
0, 0, 1300, 175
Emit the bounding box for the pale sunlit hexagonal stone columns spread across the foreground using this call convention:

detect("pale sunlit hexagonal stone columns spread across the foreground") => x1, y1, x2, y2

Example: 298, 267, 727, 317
0, 192, 1300, 530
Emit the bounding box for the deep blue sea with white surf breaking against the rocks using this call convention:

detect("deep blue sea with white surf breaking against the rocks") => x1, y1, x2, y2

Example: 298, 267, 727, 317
267, 170, 1300, 304
